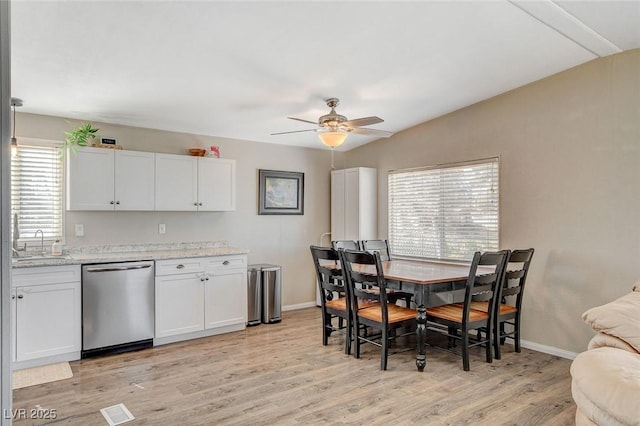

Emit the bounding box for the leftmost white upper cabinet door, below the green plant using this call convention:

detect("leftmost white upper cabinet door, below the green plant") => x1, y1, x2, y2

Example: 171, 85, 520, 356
65, 148, 115, 210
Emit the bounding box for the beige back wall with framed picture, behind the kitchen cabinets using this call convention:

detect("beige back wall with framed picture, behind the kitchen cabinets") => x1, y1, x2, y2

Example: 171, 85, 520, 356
16, 114, 342, 306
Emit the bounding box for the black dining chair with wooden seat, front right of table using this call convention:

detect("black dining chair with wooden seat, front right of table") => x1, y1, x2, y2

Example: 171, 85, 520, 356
427, 250, 509, 371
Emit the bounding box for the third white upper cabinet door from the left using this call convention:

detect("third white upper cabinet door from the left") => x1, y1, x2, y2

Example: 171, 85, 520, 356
155, 154, 198, 211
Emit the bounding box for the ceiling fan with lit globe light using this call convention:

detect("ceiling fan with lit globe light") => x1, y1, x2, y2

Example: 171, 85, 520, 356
271, 98, 393, 148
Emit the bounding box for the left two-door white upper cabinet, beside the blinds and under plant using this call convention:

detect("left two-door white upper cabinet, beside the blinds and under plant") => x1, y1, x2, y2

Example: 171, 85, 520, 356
67, 147, 155, 211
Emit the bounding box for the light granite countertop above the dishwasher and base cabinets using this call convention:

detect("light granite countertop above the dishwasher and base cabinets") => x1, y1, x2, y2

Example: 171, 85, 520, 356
12, 241, 249, 268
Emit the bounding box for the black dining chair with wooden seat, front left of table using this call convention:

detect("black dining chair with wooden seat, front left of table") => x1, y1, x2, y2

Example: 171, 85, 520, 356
339, 249, 416, 370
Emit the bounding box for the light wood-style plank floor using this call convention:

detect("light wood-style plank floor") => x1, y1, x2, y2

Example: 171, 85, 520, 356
13, 308, 575, 426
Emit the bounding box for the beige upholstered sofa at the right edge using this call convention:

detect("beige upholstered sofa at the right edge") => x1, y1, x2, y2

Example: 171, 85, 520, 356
571, 282, 640, 426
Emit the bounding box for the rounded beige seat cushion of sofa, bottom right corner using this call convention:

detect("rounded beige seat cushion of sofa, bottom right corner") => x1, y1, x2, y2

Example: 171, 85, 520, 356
571, 347, 640, 425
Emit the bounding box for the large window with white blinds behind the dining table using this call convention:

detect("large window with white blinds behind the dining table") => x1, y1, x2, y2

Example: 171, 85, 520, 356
388, 158, 499, 260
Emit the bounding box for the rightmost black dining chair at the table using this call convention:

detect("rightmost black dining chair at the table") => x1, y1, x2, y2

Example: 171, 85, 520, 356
471, 248, 534, 359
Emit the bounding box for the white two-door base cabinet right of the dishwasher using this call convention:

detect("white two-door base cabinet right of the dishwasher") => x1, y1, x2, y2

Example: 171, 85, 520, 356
154, 255, 247, 345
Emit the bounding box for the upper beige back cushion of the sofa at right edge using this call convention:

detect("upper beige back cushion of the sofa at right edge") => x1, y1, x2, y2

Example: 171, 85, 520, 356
582, 291, 640, 352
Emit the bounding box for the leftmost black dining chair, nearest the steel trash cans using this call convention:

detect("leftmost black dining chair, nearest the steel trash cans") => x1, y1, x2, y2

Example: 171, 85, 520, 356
310, 245, 352, 354
